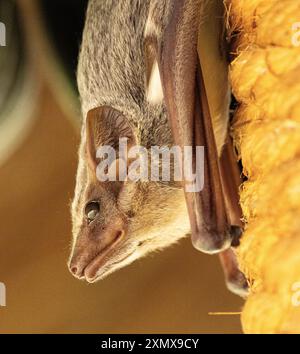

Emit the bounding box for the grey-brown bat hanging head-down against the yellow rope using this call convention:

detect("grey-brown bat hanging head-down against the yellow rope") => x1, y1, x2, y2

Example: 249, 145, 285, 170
69, 0, 247, 295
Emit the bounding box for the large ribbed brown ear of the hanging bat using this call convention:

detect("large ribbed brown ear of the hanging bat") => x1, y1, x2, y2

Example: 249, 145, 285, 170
85, 106, 136, 175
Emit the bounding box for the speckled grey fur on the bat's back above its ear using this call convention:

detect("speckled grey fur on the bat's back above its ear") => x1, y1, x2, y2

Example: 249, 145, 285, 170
78, 0, 167, 134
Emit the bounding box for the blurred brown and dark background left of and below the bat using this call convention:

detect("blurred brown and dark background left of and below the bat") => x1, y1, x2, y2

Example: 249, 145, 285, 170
0, 0, 243, 333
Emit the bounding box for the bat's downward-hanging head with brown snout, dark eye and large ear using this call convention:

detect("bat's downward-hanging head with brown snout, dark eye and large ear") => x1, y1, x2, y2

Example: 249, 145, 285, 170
69, 107, 190, 282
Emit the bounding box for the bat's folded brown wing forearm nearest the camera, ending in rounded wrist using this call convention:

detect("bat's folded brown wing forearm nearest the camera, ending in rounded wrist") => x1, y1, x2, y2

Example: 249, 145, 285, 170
159, 0, 232, 253
